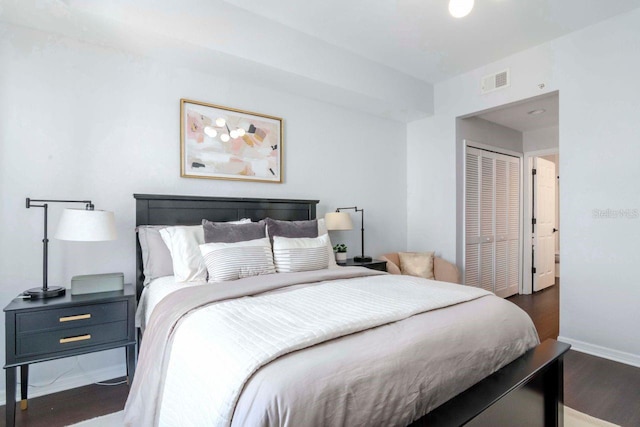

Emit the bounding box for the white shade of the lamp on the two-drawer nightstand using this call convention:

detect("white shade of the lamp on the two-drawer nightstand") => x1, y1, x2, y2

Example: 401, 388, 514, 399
55, 209, 118, 242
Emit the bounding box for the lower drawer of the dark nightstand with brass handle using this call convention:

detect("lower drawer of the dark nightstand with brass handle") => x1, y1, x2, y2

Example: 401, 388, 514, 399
16, 320, 128, 358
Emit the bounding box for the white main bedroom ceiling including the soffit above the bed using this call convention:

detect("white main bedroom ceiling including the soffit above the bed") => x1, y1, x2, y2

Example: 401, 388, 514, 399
0, 0, 640, 122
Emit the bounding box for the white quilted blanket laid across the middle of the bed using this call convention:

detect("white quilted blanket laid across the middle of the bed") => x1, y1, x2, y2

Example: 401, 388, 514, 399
160, 276, 490, 426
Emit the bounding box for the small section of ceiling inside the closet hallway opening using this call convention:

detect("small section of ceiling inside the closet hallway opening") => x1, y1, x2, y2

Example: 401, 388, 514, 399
475, 92, 559, 132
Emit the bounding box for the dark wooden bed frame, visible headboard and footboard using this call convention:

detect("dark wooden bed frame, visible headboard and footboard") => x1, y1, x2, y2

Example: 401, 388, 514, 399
133, 194, 570, 427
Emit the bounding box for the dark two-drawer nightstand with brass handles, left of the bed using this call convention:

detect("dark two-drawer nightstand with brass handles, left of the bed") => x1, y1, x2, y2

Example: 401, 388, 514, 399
4, 284, 136, 426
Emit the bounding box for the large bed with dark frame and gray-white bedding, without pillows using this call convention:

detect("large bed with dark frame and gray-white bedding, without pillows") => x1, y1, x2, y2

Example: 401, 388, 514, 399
125, 195, 568, 425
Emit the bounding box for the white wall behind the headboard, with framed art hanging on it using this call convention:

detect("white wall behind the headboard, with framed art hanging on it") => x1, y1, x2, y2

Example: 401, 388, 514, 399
0, 25, 406, 404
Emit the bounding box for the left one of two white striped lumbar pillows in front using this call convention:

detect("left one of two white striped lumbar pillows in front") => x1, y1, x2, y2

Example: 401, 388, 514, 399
200, 237, 276, 283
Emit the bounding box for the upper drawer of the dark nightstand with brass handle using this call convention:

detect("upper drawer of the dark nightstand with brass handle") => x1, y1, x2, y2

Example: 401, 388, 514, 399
16, 301, 127, 334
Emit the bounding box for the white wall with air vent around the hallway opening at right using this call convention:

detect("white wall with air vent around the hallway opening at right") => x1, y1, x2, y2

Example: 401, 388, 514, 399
407, 9, 640, 366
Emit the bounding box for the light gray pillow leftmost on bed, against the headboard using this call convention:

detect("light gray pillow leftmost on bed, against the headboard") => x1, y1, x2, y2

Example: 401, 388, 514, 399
136, 225, 173, 286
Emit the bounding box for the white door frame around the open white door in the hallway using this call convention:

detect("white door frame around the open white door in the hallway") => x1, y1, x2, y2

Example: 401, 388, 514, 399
520, 147, 560, 294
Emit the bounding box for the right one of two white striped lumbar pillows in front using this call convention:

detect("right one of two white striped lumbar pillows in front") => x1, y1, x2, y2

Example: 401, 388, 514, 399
273, 234, 329, 273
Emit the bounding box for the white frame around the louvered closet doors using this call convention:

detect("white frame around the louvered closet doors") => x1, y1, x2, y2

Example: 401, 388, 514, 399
461, 139, 524, 294
